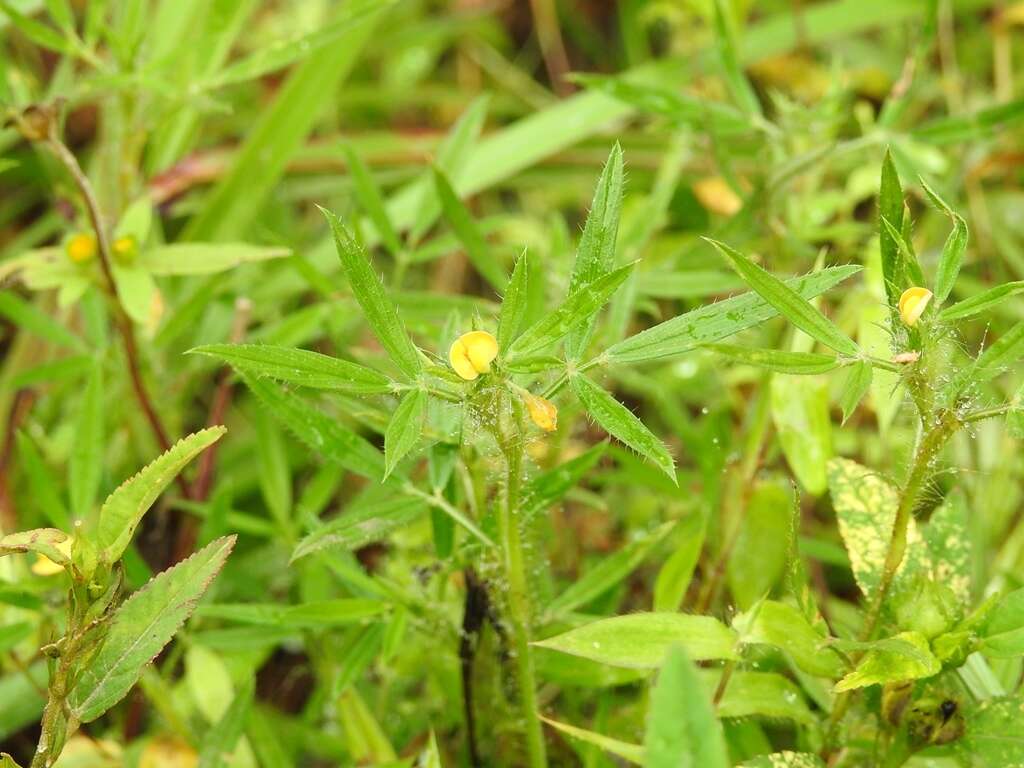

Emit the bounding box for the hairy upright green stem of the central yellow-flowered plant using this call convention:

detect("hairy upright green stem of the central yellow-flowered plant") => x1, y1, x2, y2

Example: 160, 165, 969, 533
500, 411, 548, 768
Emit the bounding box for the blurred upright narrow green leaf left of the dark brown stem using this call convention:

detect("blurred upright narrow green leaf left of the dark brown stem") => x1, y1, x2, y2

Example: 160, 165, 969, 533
68, 364, 104, 520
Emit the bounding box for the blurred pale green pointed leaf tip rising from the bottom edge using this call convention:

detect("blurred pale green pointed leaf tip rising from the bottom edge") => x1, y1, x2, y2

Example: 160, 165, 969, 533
643, 645, 730, 768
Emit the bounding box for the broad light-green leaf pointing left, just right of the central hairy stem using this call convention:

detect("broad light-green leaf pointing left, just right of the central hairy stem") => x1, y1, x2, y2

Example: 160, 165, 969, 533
534, 613, 737, 670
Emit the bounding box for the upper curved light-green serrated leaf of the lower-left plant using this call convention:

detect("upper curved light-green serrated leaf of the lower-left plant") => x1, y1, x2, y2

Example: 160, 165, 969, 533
95, 427, 227, 563
